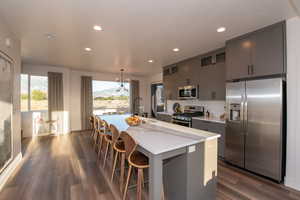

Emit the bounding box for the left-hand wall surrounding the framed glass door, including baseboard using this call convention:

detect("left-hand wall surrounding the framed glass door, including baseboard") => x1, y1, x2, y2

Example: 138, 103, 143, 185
0, 19, 21, 189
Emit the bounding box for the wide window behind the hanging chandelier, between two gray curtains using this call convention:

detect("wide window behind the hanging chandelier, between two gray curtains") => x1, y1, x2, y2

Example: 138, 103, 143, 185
93, 80, 130, 115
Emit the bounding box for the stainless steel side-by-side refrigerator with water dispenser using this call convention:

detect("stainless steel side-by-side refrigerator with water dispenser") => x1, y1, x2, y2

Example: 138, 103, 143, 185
225, 78, 285, 182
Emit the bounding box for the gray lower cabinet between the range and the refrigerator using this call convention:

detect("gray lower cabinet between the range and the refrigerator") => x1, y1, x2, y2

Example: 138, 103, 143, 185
192, 119, 225, 158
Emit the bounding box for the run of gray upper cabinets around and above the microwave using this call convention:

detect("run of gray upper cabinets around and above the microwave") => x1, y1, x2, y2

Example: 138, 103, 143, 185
163, 48, 226, 100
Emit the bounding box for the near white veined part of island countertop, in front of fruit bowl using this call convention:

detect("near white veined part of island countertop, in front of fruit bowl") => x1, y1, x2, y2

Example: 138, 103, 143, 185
127, 119, 220, 155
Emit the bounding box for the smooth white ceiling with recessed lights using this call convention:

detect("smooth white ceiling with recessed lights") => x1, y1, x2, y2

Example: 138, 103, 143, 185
0, 0, 296, 75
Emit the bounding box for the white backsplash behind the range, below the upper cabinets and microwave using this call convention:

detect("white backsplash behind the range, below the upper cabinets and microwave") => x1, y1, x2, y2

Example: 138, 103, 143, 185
166, 100, 225, 117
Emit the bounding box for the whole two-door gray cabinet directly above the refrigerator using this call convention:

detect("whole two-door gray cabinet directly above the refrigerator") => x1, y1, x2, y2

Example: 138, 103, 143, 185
226, 22, 286, 80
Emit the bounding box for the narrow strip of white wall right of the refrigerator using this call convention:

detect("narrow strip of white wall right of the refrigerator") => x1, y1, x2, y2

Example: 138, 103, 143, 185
285, 17, 300, 190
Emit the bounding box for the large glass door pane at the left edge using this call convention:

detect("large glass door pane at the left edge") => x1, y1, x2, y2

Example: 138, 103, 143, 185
0, 55, 13, 173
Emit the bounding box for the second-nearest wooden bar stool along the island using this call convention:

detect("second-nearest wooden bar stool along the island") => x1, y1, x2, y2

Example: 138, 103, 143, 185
111, 131, 126, 192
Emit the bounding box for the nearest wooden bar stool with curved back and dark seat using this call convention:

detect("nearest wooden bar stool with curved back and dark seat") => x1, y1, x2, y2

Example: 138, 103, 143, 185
120, 131, 149, 200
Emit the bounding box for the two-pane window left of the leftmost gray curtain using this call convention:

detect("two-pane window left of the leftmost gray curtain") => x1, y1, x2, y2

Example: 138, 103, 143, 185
21, 74, 48, 112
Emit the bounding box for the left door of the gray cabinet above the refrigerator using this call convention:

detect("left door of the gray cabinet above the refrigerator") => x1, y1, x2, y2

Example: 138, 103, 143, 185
226, 37, 252, 80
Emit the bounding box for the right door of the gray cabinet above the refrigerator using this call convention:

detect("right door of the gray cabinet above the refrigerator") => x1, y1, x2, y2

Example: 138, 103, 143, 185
251, 23, 285, 76
